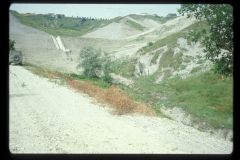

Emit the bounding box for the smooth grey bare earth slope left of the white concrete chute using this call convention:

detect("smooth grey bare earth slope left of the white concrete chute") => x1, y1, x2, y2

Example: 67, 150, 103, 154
9, 13, 81, 74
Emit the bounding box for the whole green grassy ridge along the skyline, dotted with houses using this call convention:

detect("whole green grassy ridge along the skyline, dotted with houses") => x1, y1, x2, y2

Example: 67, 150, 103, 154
10, 10, 177, 37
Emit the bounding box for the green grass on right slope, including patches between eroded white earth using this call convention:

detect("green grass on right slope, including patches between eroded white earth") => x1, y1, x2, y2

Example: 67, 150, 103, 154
113, 21, 233, 129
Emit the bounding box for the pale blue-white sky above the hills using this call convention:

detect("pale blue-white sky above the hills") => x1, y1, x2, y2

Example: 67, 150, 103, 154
9, 3, 180, 19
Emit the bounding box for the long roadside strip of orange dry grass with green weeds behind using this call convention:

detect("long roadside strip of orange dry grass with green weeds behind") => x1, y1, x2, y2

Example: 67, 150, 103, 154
23, 63, 156, 116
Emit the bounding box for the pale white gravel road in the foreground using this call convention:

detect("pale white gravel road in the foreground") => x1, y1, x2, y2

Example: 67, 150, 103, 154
9, 65, 233, 154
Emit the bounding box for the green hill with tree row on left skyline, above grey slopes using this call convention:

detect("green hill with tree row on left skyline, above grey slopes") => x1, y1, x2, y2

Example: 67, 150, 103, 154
9, 10, 112, 37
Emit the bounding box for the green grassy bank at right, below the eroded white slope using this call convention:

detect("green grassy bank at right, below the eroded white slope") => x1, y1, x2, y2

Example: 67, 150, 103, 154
122, 71, 233, 129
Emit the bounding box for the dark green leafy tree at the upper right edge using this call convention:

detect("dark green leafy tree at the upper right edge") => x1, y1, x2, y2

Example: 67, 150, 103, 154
178, 4, 234, 76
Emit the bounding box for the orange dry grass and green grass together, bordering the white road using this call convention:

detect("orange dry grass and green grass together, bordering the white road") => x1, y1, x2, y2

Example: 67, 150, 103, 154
23, 57, 233, 129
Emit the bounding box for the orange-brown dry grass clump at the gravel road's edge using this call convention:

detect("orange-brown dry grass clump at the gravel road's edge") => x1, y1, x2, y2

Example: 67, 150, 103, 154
68, 77, 156, 116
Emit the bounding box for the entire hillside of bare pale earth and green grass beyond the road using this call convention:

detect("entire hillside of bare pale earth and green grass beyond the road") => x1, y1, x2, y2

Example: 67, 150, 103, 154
10, 9, 233, 139
